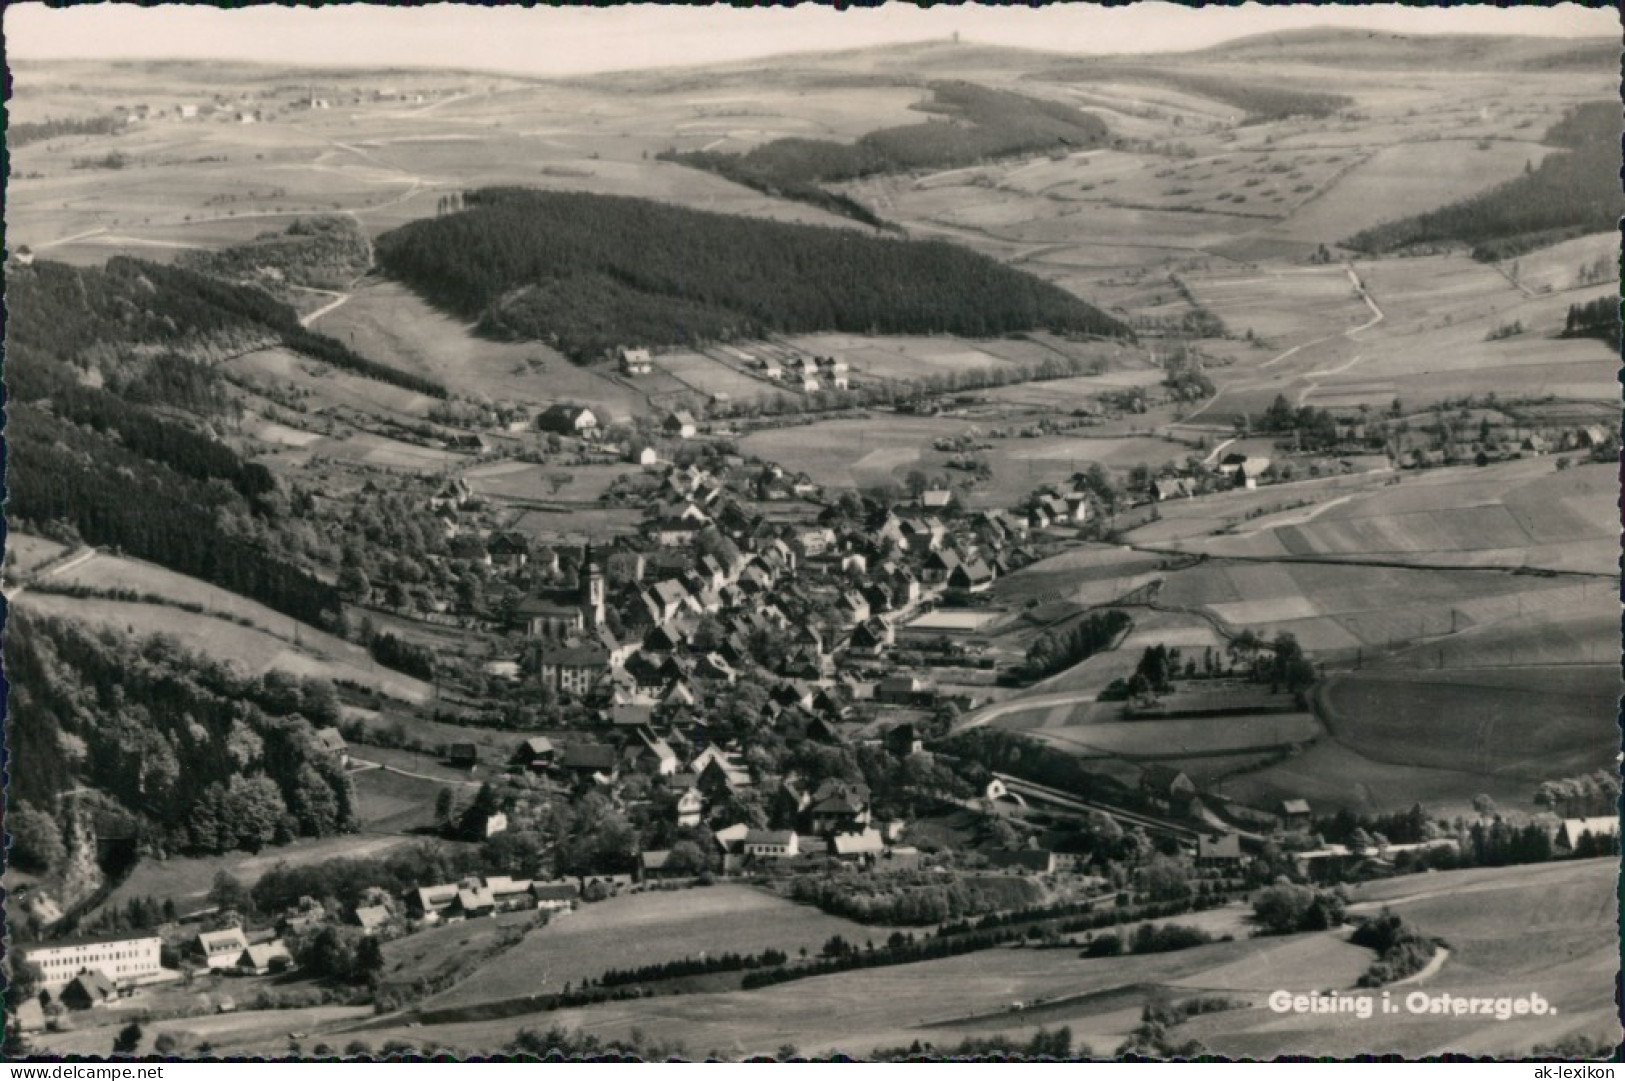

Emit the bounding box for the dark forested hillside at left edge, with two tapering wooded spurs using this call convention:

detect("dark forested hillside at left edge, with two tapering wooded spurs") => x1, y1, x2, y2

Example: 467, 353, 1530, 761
5, 258, 359, 626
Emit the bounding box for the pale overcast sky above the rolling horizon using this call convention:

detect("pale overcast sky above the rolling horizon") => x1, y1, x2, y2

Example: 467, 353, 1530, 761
3, 3, 1620, 75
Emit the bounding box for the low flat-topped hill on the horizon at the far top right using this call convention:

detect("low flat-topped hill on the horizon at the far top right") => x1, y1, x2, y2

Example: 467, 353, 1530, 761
1181, 26, 1620, 72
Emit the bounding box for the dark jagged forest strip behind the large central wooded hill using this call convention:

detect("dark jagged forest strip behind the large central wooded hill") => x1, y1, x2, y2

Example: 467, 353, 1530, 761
661, 81, 1108, 226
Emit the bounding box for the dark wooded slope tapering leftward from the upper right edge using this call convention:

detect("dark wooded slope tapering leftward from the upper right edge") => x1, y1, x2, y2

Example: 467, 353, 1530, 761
1342, 101, 1625, 260
